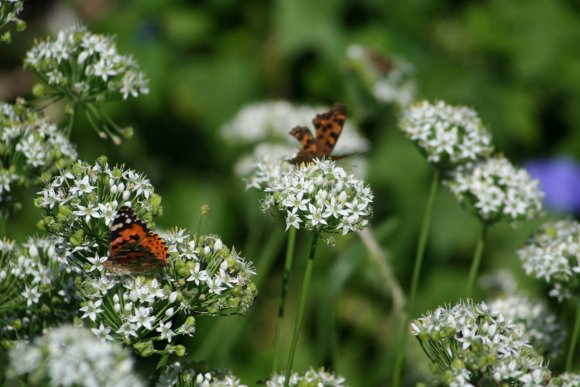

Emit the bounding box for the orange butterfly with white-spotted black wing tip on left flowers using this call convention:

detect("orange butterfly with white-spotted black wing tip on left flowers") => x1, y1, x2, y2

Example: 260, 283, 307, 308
104, 206, 169, 274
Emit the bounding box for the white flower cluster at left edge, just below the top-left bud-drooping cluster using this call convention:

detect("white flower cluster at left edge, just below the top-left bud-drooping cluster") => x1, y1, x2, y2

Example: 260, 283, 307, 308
0, 103, 77, 217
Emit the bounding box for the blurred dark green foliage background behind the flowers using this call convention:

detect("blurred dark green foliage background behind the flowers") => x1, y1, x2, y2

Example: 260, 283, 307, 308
0, 0, 580, 386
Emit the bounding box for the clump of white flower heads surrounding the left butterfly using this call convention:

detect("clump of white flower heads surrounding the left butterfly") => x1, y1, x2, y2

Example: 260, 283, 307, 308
32, 158, 256, 356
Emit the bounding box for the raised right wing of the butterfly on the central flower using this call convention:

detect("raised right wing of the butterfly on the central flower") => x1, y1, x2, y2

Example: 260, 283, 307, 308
312, 104, 346, 157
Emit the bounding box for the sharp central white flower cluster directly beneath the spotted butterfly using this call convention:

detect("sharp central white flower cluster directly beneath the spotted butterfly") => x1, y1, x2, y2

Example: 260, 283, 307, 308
263, 160, 373, 234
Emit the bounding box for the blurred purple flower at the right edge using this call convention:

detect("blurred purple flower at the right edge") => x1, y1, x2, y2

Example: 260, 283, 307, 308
526, 157, 580, 214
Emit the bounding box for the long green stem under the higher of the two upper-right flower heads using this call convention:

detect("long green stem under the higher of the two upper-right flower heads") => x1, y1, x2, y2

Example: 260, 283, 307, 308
391, 169, 440, 387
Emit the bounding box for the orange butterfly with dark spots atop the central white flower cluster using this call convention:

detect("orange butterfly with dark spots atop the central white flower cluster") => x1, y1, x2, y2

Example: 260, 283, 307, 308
289, 104, 346, 164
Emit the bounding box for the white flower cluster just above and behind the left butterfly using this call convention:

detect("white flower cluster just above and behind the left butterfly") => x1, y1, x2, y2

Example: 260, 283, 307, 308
35, 157, 161, 271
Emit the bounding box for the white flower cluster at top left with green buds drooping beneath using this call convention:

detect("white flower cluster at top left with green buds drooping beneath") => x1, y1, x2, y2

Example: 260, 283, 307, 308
24, 25, 149, 144
